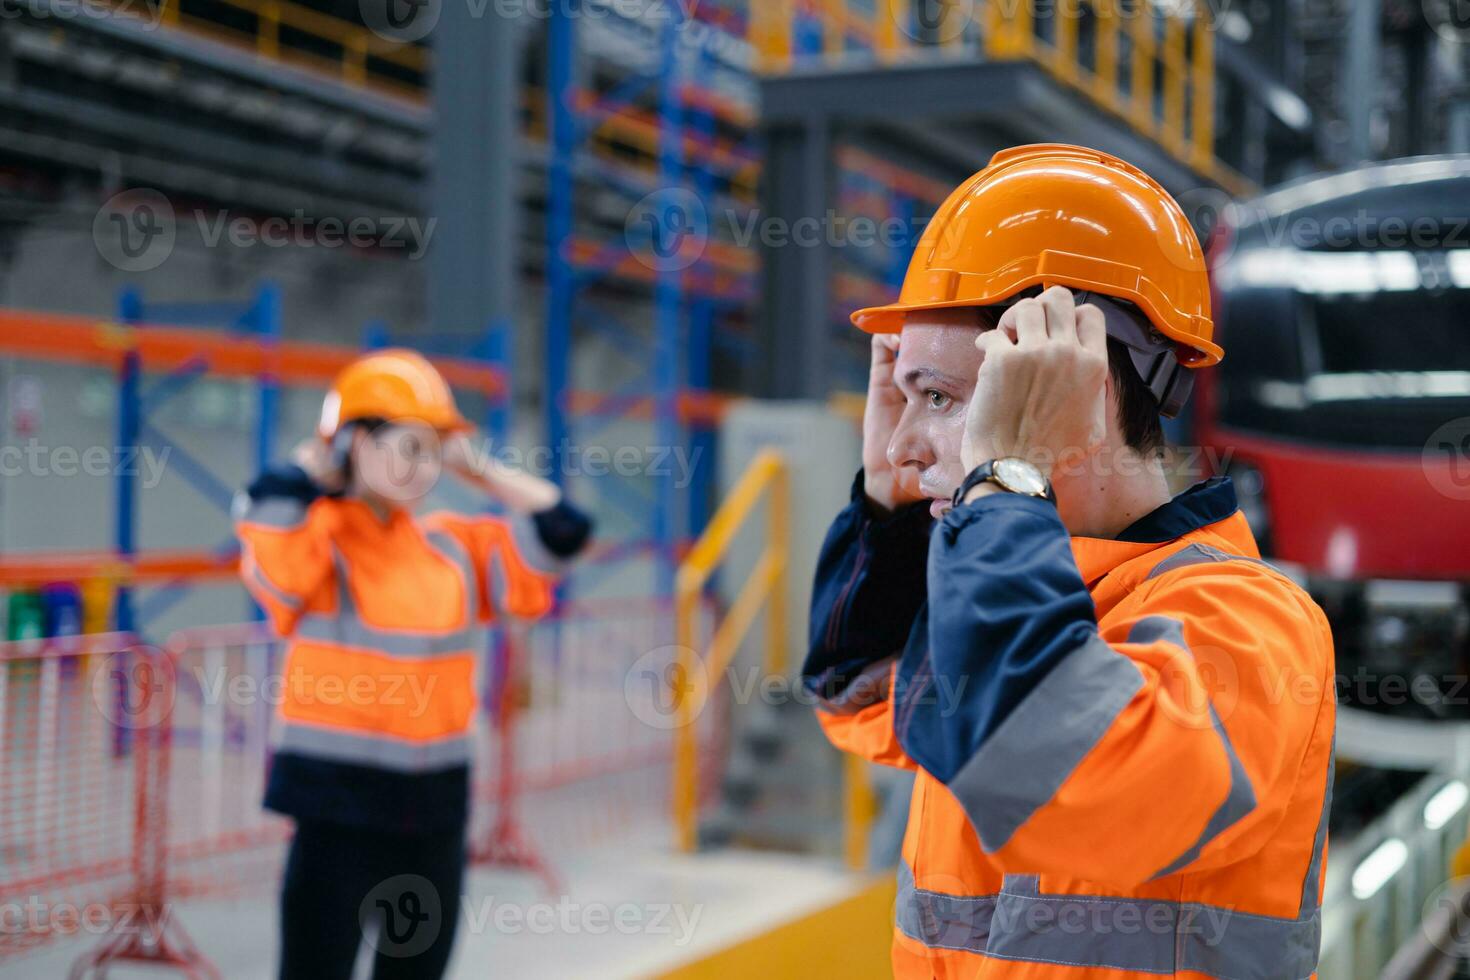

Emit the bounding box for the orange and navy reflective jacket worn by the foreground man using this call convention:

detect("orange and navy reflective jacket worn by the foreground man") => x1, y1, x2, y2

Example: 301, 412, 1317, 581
804, 475, 1335, 980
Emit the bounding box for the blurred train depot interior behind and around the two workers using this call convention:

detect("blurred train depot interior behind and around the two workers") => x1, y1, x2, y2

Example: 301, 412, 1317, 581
0, 0, 1470, 980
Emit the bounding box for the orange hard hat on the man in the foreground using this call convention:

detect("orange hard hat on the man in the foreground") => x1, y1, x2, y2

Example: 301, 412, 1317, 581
853, 143, 1225, 367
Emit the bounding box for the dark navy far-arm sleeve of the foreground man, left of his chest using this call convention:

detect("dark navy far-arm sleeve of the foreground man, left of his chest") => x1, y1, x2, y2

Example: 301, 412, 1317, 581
801, 472, 933, 768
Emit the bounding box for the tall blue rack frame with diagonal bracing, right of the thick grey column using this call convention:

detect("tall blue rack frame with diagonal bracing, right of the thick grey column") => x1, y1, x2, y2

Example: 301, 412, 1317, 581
544, 0, 746, 594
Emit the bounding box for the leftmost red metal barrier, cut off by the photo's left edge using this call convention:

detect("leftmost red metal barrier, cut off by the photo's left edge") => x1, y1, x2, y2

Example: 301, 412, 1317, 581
0, 633, 216, 977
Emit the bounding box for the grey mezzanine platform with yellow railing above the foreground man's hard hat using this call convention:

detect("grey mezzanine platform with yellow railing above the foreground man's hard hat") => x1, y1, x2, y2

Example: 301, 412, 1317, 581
760, 0, 1310, 397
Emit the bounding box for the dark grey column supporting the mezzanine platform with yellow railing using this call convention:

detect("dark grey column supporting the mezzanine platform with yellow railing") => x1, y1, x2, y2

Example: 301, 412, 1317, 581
759, 115, 833, 398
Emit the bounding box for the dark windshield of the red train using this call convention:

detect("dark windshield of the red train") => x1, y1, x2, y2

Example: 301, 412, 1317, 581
1220, 253, 1470, 450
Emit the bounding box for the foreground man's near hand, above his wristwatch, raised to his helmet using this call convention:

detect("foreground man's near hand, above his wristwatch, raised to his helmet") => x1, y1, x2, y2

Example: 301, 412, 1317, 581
960, 287, 1107, 476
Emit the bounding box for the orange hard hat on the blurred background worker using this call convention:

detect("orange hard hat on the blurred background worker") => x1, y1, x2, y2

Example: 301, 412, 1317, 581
316, 348, 470, 439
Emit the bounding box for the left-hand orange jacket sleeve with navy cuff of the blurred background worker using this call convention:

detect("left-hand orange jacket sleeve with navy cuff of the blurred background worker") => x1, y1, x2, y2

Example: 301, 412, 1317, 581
235, 466, 332, 635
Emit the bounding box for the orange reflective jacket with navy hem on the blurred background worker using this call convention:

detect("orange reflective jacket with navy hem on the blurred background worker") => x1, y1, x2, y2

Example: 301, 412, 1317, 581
237, 470, 557, 832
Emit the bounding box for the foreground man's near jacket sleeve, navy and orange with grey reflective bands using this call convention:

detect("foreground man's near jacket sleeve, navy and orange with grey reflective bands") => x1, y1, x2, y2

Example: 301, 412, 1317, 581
895, 494, 1333, 886
